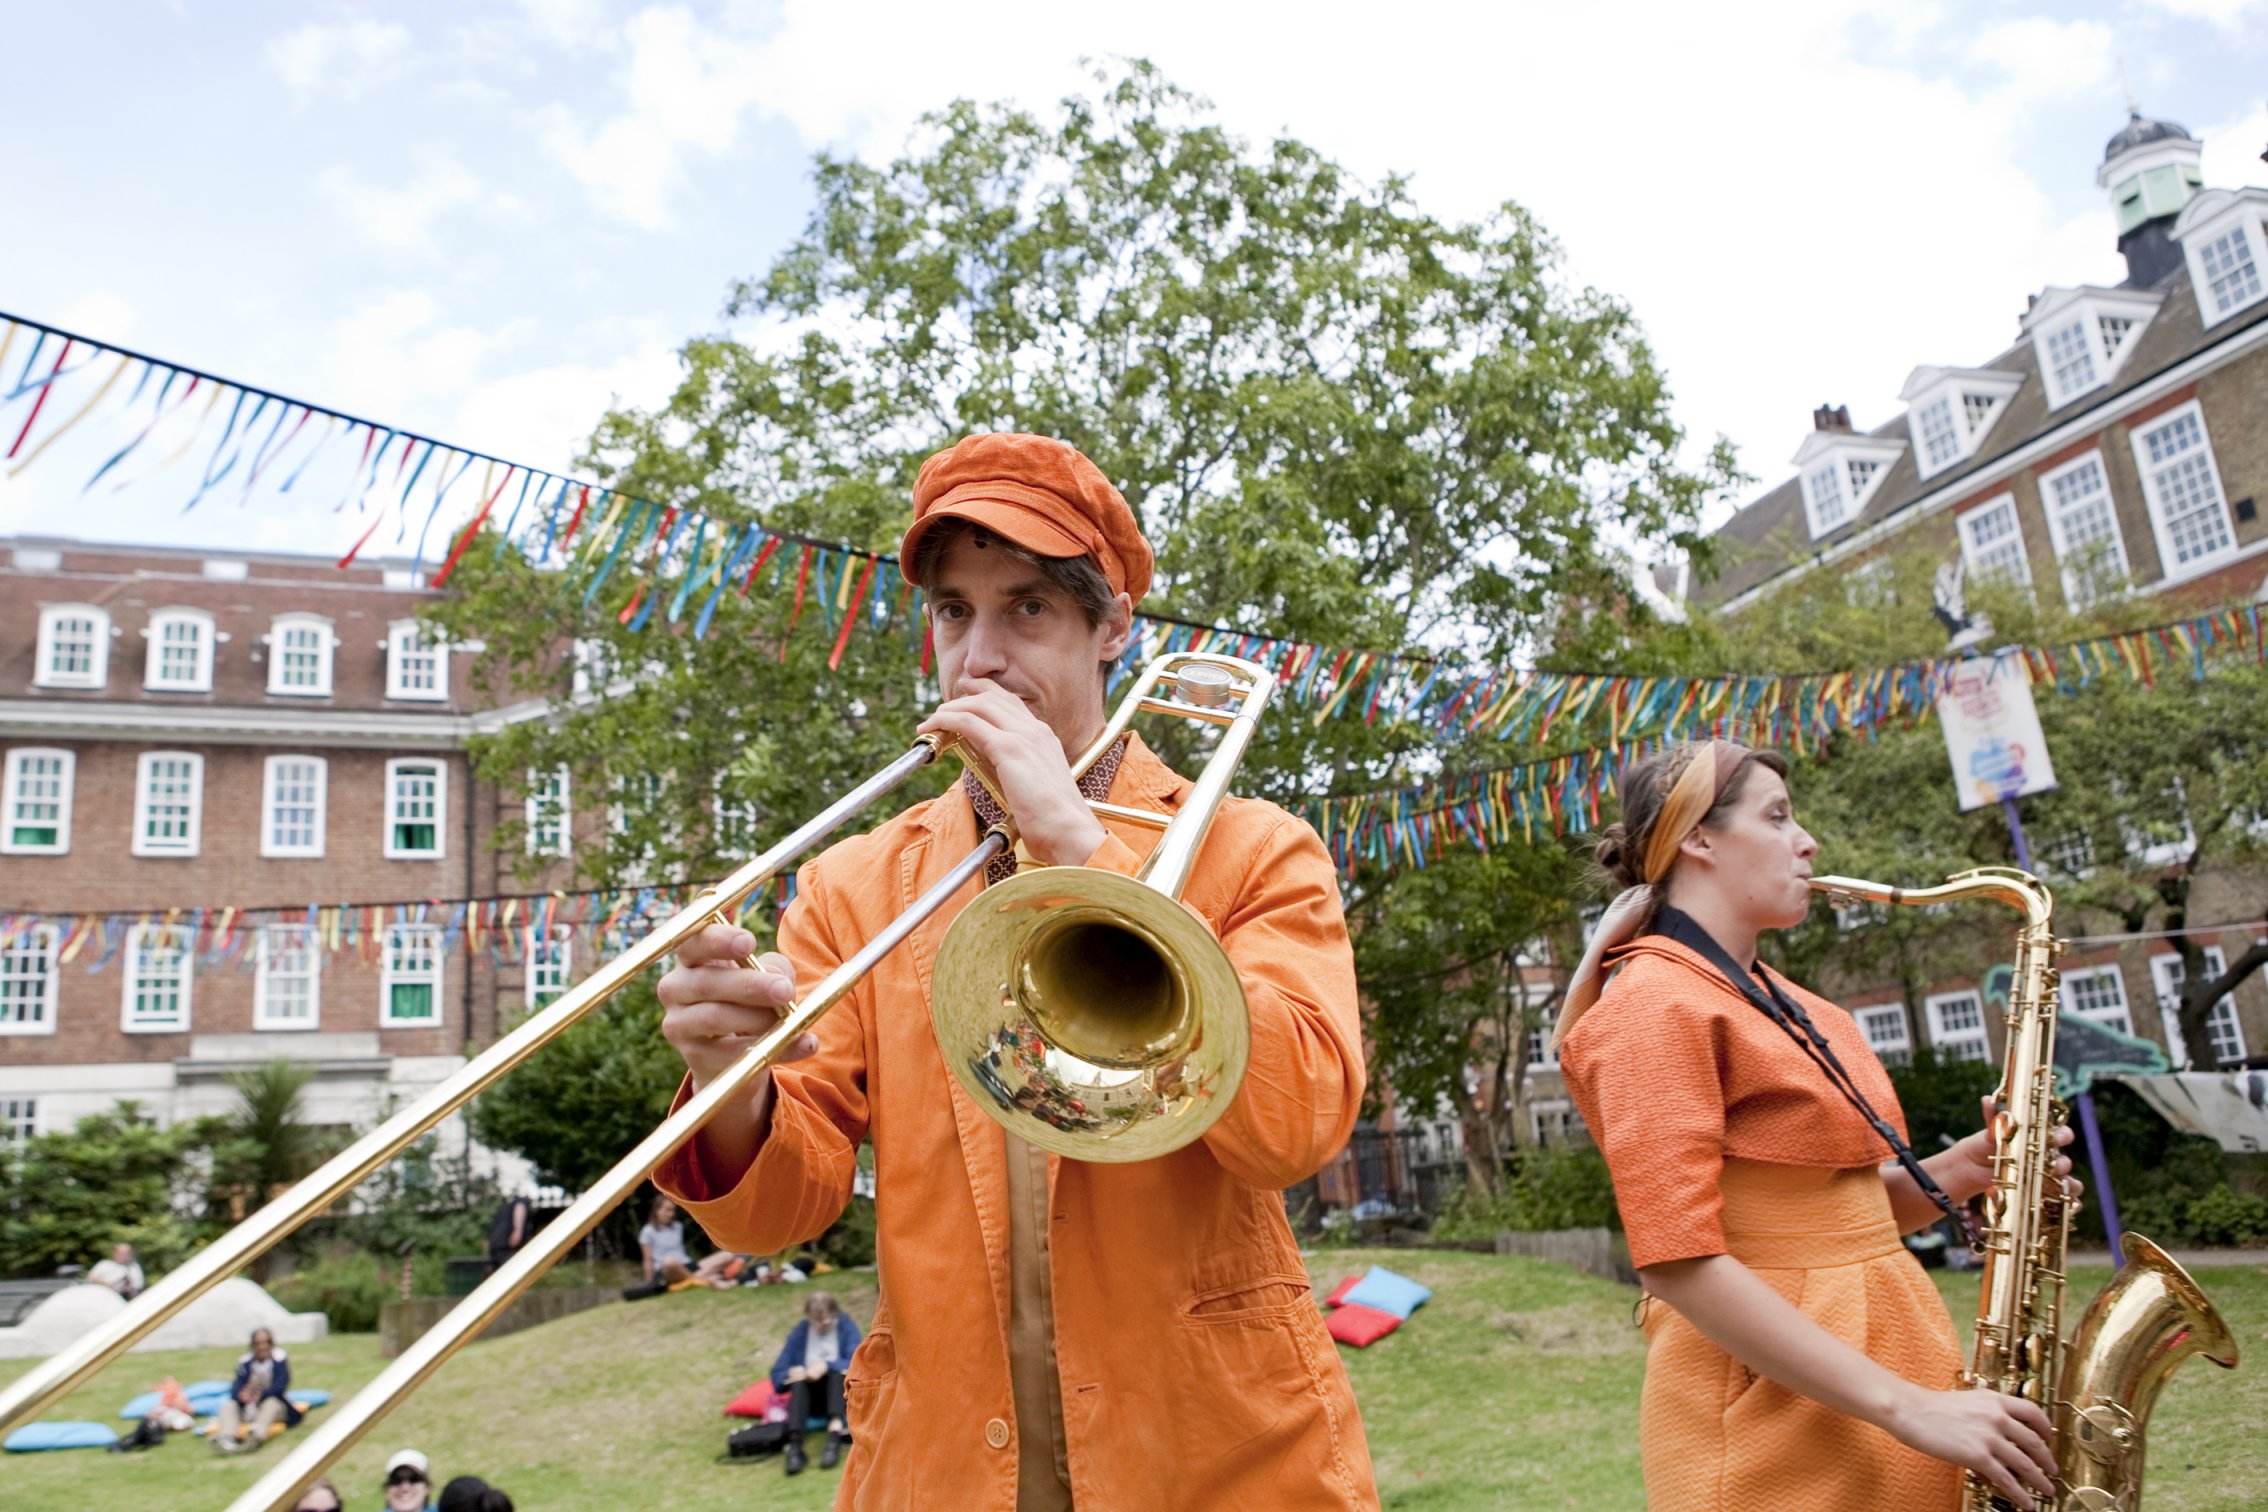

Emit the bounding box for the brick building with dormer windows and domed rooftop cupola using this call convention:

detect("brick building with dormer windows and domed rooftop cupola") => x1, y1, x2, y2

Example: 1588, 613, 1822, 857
1658, 113, 2268, 1063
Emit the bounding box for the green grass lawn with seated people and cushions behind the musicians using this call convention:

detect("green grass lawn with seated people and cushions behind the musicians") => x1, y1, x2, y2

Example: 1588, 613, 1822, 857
0, 1251, 2268, 1512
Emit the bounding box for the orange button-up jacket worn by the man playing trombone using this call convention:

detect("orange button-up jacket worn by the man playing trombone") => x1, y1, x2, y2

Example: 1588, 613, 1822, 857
655, 739, 1379, 1512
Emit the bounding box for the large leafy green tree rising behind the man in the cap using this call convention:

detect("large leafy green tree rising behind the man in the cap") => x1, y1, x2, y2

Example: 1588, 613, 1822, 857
442, 63, 1730, 1196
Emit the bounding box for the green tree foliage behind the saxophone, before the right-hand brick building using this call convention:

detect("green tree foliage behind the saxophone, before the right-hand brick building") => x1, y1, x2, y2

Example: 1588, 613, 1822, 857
1669, 551, 2268, 1065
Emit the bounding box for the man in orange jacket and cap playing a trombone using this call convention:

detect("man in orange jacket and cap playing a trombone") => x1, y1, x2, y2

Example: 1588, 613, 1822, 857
655, 435, 1377, 1512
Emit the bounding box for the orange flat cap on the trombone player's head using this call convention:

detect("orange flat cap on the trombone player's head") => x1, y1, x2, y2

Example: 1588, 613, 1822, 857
898, 433, 1152, 603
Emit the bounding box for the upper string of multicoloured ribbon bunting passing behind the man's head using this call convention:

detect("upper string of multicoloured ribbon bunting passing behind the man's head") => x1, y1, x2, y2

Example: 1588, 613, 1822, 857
0, 303, 2263, 757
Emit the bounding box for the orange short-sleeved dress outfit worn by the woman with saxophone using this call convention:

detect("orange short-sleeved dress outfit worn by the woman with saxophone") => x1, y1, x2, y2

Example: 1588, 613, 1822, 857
1560, 936, 1962, 1512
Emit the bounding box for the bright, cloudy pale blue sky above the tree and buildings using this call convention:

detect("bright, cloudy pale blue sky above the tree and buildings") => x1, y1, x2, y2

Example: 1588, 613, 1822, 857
0, 0, 2268, 549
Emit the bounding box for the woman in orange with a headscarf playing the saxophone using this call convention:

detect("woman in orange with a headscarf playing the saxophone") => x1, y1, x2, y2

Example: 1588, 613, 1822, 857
1558, 741, 2071, 1512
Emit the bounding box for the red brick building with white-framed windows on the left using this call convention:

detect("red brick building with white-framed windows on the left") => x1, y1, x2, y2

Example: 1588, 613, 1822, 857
0, 537, 587, 1140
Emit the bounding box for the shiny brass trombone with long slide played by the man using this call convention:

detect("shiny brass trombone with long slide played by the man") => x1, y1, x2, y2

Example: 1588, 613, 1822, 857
0, 653, 1275, 1512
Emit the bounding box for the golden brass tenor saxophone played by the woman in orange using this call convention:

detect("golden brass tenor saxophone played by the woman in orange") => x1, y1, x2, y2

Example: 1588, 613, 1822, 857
1812, 866, 2236, 1512
